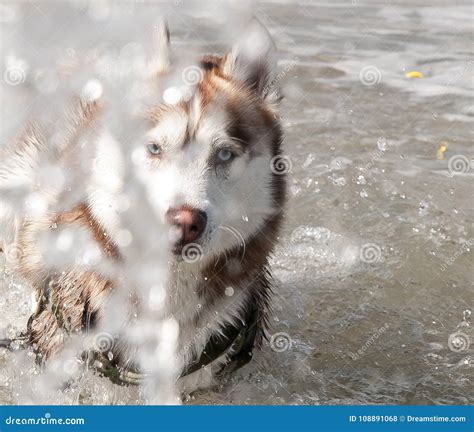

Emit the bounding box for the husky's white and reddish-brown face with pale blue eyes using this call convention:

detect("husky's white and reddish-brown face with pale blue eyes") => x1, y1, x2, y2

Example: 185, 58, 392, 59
143, 22, 283, 260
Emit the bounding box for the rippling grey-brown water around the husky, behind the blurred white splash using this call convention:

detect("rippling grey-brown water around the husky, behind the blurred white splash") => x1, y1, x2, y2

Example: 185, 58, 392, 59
0, 0, 474, 404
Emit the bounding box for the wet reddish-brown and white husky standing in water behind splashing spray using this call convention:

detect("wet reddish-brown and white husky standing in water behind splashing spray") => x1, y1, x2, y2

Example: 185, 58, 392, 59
0, 20, 285, 392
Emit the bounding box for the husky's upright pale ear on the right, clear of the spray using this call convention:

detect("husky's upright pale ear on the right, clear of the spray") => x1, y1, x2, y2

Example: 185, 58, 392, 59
223, 18, 277, 99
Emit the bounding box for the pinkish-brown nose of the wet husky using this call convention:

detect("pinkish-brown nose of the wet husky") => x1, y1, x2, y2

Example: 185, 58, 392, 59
166, 207, 207, 246
